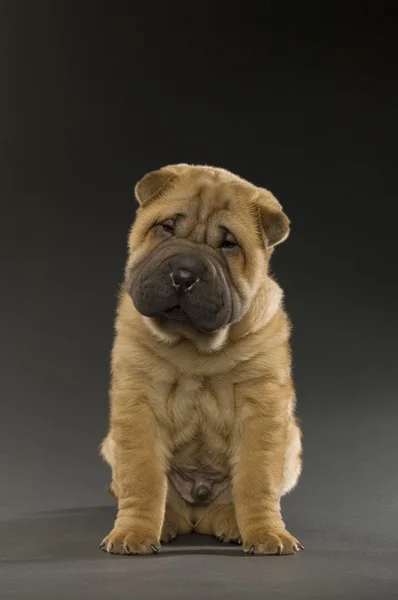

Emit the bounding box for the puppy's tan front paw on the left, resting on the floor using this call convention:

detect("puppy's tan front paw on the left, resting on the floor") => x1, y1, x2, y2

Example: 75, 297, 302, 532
99, 526, 160, 554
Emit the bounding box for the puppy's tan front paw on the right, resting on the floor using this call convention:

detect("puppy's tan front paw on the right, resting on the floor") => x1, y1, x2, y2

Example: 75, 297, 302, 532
243, 528, 304, 555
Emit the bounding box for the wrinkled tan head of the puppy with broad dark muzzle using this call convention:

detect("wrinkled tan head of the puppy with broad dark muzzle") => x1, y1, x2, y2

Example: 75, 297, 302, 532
125, 165, 289, 334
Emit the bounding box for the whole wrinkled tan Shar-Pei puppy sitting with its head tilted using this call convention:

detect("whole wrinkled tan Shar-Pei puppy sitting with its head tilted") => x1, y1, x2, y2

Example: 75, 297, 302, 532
100, 164, 302, 554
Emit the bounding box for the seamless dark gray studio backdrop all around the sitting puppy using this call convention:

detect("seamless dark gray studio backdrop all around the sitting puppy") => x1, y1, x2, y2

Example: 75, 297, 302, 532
0, 0, 398, 600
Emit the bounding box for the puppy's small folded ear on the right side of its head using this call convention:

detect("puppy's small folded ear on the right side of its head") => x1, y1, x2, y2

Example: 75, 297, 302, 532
256, 189, 290, 248
